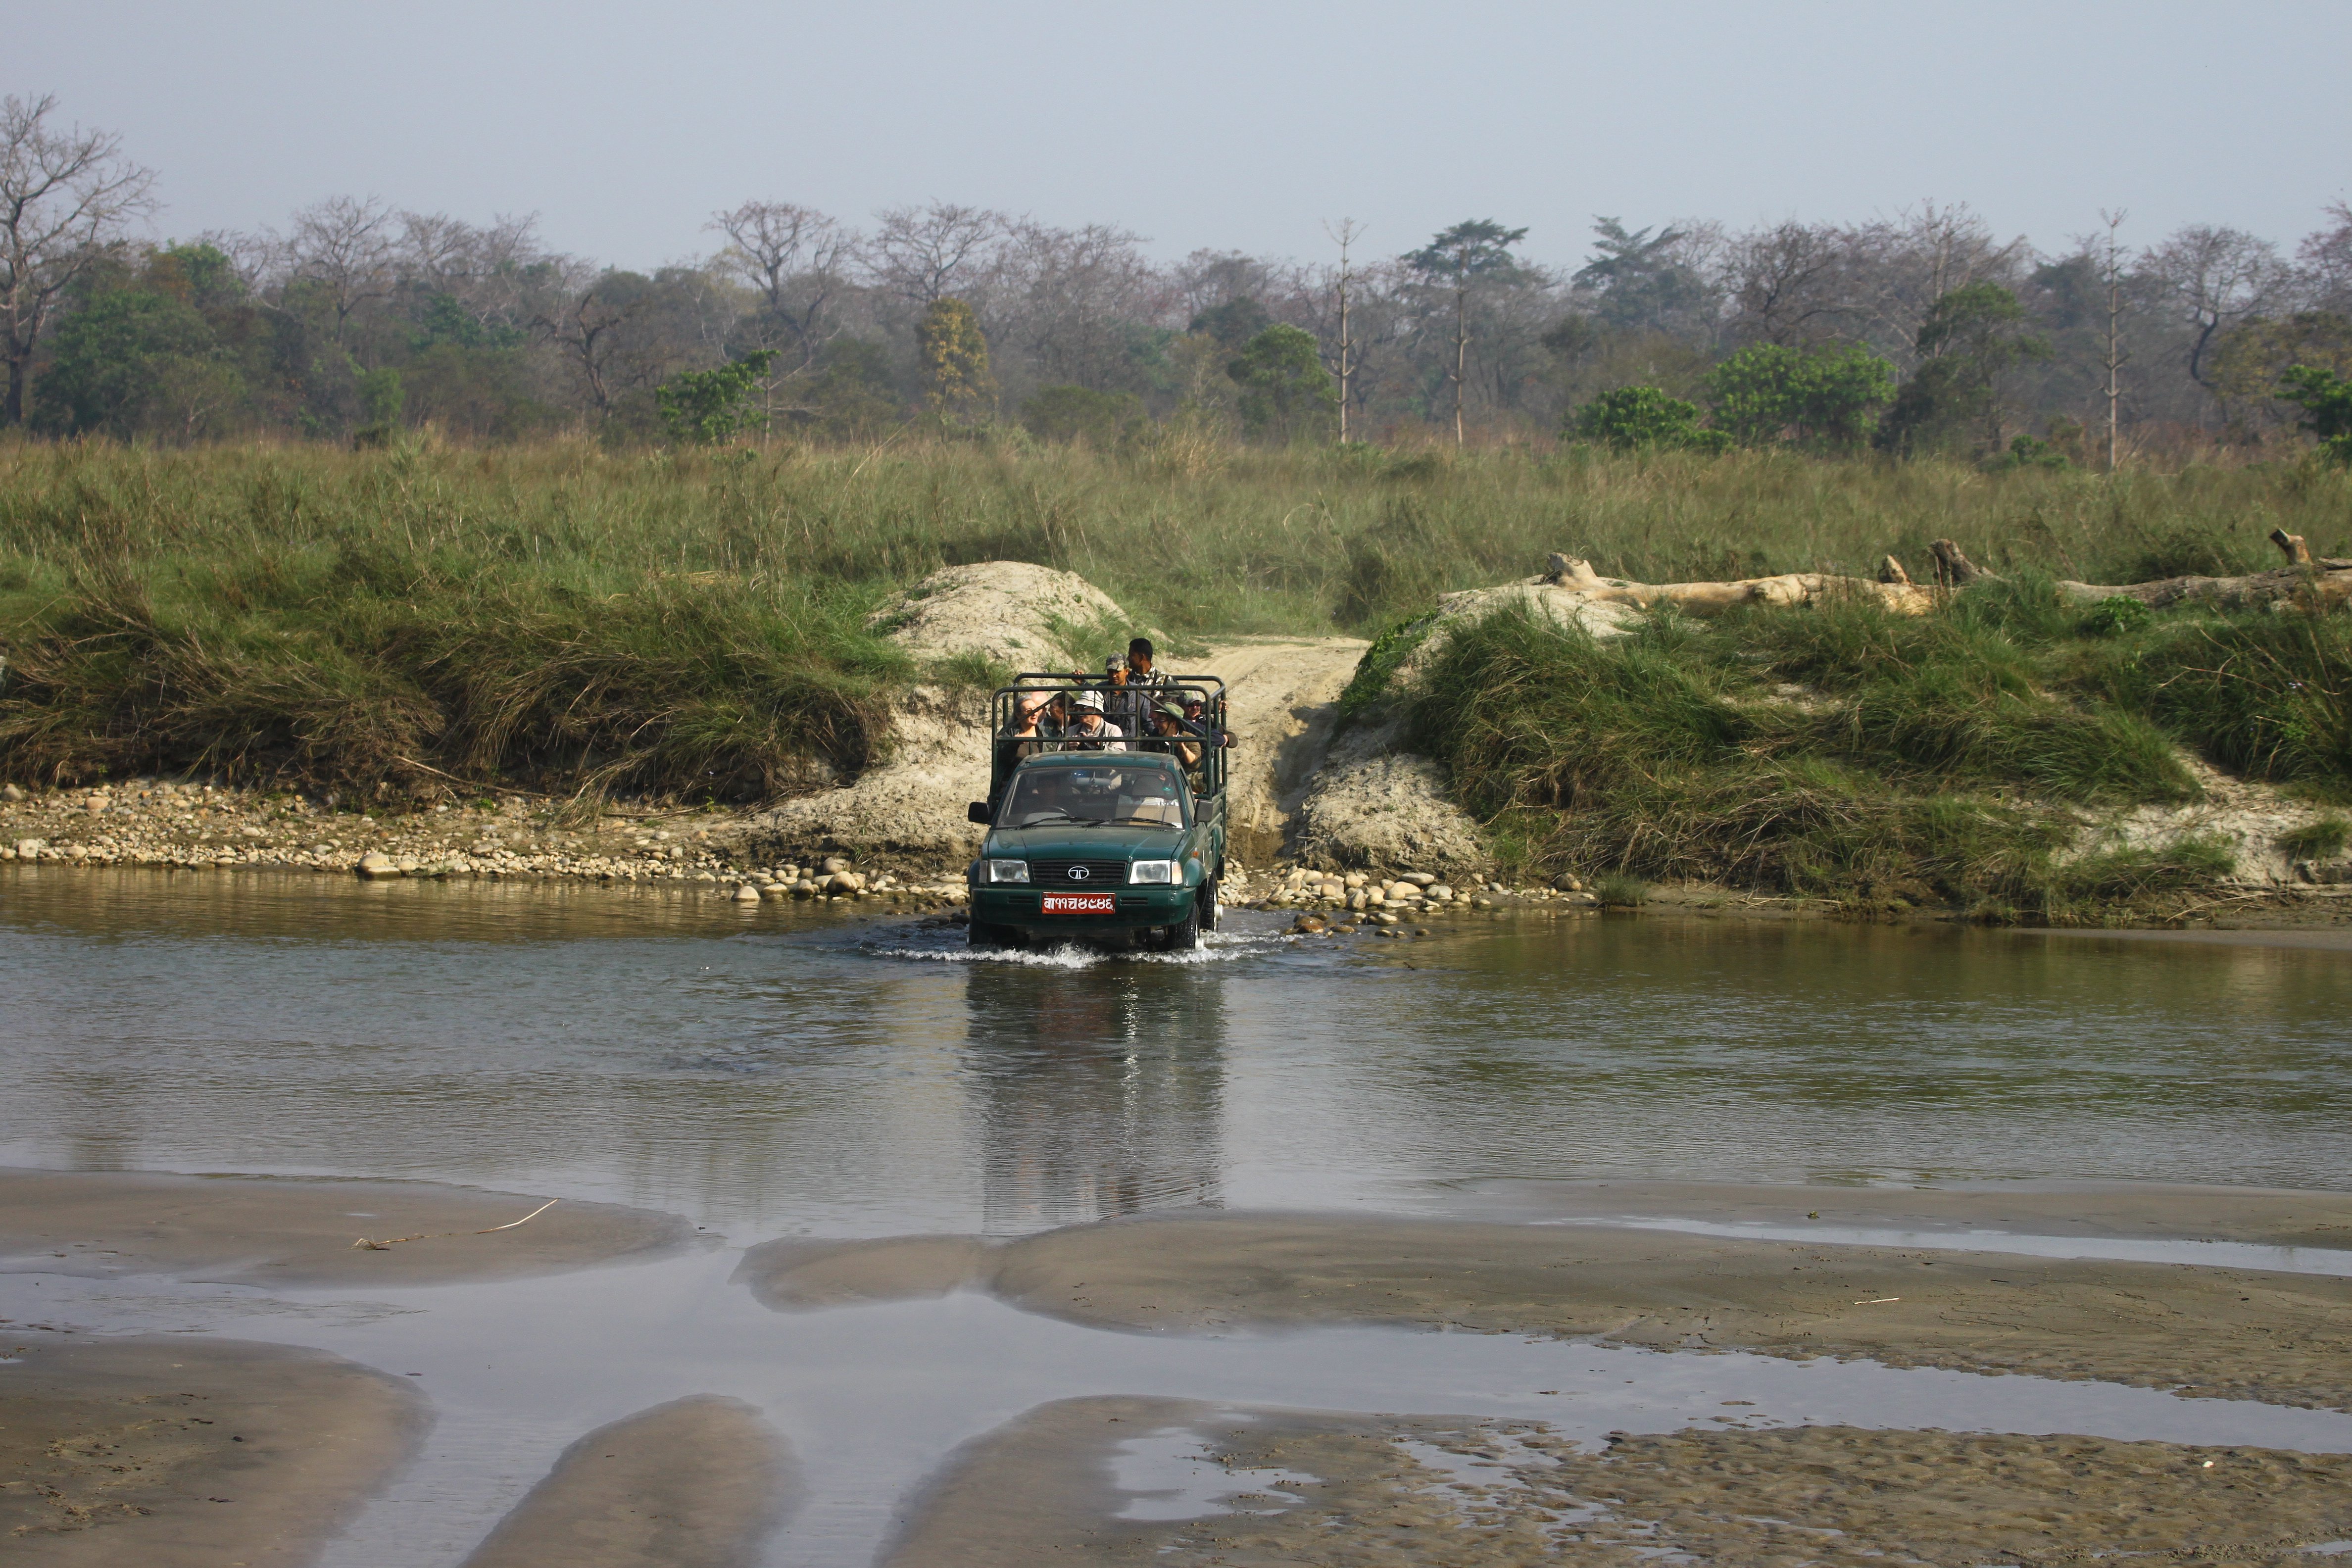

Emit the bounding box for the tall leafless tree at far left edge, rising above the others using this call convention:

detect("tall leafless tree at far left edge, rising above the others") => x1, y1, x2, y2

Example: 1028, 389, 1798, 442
0, 97, 155, 426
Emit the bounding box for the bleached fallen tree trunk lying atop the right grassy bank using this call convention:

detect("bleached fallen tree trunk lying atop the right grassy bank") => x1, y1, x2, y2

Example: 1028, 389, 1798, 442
1536, 529, 2352, 616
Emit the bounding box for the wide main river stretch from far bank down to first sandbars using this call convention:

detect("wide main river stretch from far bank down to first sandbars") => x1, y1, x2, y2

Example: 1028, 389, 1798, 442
0, 868, 2352, 1239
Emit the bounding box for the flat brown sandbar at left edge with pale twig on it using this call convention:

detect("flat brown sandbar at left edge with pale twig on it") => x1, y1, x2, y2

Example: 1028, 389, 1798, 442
0, 1171, 694, 1286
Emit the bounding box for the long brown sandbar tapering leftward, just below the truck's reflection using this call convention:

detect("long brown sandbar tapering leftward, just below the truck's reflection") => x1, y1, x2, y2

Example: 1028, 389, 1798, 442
736, 1194, 2352, 1411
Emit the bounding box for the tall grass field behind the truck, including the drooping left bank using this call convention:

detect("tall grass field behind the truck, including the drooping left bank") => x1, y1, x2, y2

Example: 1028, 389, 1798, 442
0, 437, 2352, 792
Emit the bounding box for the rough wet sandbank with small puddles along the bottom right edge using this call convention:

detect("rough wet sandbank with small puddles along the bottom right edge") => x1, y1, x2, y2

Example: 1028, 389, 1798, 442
882, 1399, 2352, 1568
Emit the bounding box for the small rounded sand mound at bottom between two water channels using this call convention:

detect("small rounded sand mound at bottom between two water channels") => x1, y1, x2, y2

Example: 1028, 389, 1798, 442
466, 1394, 797, 1568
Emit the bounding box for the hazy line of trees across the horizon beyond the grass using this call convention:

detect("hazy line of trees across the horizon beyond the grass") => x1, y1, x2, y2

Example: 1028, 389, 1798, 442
0, 98, 2352, 465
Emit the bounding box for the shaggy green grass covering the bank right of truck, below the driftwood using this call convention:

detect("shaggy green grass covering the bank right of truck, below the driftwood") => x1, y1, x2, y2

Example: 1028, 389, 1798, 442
1409, 594, 2340, 919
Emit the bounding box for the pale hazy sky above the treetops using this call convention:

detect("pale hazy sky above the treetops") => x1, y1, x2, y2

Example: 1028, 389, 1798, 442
18, 0, 2352, 266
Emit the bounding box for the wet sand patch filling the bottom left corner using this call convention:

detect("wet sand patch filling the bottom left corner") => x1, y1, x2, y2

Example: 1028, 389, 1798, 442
0, 1335, 426, 1568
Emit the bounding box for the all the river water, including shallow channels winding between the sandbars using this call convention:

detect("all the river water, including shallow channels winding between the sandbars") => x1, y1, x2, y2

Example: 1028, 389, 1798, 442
0, 868, 2352, 1566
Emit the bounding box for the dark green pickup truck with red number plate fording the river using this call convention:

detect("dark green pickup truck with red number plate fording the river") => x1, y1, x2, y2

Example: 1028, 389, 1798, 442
969, 675, 1228, 952
